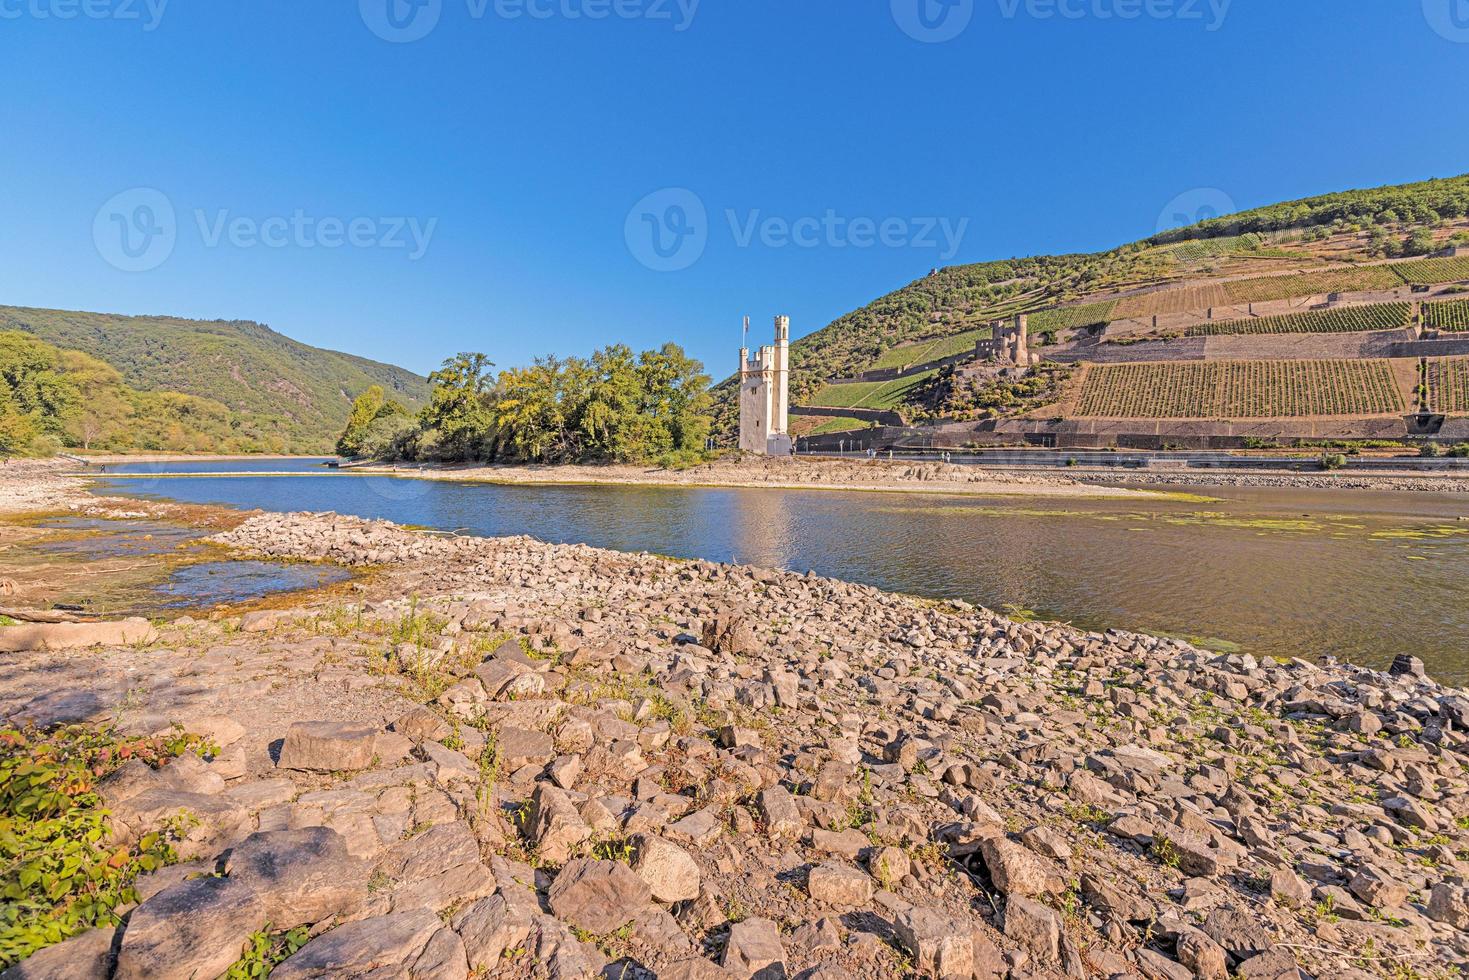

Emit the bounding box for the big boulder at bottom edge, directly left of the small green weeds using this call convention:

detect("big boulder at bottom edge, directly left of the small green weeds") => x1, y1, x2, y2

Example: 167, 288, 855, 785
115, 877, 267, 980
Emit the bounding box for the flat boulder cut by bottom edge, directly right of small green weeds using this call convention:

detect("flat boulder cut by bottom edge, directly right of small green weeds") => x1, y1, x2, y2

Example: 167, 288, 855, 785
271, 908, 444, 980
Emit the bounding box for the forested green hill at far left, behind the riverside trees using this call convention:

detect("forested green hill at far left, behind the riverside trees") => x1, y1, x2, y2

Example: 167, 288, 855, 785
0, 307, 427, 453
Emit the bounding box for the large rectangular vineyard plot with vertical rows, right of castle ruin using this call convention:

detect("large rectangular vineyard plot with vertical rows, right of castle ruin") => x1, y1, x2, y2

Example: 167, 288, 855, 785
1075, 360, 1407, 419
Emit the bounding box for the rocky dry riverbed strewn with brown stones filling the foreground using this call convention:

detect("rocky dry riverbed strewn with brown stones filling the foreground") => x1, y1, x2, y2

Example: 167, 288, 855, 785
0, 514, 1469, 980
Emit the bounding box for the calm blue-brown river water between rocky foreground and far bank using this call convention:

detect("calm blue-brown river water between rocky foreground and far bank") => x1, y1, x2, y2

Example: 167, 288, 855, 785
91, 461, 1469, 683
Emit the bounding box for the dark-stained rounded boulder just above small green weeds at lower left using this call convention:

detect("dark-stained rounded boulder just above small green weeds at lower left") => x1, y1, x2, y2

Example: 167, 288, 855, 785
225, 827, 367, 930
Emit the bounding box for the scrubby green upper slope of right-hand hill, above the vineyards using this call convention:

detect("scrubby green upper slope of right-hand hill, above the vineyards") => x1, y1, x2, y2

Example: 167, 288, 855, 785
714, 175, 1469, 441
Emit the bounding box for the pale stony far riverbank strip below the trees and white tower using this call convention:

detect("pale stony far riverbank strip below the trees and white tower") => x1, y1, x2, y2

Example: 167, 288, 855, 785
353, 454, 1169, 498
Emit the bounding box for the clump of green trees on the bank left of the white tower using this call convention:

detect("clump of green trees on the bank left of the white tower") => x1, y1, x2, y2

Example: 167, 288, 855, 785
336, 344, 712, 464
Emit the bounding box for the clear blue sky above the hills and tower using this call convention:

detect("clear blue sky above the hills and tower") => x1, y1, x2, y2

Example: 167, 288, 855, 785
0, 0, 1469, 376
